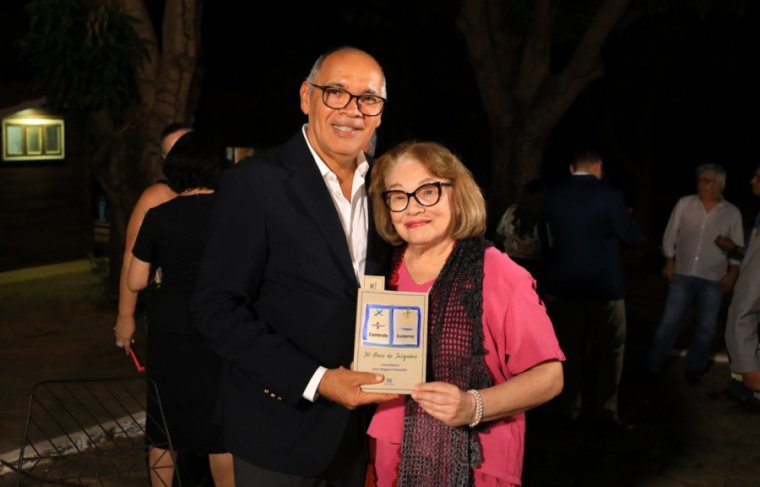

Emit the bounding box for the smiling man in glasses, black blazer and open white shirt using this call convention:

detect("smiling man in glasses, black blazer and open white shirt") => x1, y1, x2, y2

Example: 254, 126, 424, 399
193, 47, 396, 486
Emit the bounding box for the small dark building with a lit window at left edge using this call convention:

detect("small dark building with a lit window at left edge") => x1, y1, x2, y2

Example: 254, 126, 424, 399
0, 92, 97, 272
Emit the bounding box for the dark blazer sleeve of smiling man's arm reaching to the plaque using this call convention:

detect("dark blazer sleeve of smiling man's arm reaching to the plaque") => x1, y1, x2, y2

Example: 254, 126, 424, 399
192, 167, 320, 403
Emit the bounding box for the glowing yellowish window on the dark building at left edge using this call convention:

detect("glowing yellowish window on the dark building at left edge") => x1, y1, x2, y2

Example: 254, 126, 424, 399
3, 110, 66, 161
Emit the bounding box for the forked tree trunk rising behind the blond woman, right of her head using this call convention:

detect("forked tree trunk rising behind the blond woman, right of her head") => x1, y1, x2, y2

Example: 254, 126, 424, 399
457, 0, 629, 234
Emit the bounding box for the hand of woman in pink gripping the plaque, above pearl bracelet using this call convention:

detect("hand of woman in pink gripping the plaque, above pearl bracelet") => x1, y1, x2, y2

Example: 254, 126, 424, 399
412, 382, 475, 426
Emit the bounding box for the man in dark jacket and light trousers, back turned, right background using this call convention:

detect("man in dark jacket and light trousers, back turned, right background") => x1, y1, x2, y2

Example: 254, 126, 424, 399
542, 151, 639, 428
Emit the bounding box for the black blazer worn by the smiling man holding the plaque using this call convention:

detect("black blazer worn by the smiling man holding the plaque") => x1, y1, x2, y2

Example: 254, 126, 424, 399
192, 131, 389, 476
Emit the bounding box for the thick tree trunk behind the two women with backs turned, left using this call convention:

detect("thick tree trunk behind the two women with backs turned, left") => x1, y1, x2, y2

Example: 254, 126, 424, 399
90, 0, 200, 290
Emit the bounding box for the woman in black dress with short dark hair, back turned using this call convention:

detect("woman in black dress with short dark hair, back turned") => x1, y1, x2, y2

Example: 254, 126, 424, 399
127, 132, 234, 487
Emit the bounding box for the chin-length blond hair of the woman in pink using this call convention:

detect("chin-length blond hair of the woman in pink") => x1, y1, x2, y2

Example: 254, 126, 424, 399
369, 141, 486, 245
